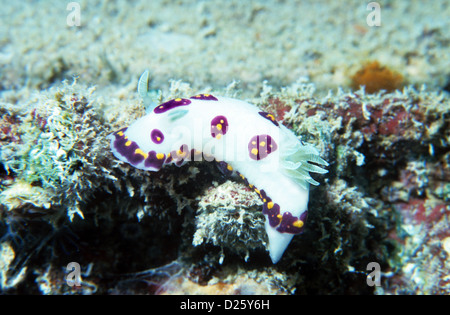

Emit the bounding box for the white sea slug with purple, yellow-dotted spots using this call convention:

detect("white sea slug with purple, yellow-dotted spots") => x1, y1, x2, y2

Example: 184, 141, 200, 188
108, 76, 328, 263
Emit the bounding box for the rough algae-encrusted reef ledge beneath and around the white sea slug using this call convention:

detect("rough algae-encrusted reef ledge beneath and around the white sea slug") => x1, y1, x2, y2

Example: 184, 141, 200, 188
0, 75, 450, 294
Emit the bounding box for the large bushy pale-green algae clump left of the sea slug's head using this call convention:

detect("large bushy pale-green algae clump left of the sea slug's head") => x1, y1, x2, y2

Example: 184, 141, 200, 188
0, 81, 109, 222
